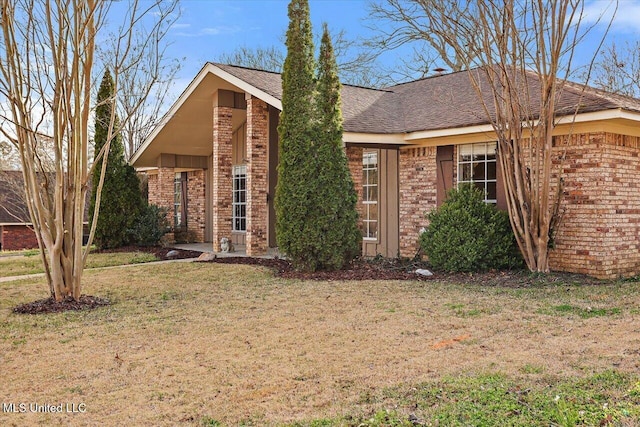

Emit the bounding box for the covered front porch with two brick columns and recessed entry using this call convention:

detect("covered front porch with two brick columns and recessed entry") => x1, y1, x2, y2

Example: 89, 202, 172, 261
147, 89, 278, 256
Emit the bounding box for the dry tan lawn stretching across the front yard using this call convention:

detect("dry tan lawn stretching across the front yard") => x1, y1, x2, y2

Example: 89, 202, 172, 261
0, 263, 640, 425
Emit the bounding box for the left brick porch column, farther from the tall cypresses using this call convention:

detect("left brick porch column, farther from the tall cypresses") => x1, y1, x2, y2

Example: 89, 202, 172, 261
212, 106, 233, 251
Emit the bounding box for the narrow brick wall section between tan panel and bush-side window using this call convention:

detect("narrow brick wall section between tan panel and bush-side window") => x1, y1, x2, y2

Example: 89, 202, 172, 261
399, 147, 438, 257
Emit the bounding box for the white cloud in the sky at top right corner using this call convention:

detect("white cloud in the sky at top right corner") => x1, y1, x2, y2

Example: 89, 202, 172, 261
583, 0, 640, 33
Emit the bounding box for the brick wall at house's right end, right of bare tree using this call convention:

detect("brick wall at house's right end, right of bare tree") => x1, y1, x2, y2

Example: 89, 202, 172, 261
550, 132, 640, 278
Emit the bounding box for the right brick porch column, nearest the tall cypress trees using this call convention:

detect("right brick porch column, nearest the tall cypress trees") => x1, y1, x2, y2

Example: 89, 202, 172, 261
246, 96, 269, 255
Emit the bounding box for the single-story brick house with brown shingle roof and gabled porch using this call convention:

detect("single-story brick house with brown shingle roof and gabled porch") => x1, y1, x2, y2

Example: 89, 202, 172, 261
132, 63, 640, 278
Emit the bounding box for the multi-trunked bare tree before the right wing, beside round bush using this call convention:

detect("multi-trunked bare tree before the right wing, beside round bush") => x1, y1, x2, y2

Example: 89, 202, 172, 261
376, 0, 608, 272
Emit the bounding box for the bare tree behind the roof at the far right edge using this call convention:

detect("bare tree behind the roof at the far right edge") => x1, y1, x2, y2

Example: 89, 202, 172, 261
593, 40, 640, 98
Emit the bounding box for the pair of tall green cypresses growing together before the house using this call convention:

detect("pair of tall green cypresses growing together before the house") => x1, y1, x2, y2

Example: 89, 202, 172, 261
275, 0, 361, 271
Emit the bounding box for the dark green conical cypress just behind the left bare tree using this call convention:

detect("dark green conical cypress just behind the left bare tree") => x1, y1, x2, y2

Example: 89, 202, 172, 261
89, 70, 144, 249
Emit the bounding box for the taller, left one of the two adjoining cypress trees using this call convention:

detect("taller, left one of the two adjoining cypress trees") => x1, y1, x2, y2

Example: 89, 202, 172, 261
275, 0, 319, 270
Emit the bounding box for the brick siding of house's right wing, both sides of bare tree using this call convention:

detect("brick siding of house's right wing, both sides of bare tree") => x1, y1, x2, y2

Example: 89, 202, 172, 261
392, 132, 640, 279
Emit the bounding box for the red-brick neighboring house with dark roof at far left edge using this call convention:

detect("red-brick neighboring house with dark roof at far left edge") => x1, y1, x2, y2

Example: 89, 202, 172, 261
0, 171, 38, 251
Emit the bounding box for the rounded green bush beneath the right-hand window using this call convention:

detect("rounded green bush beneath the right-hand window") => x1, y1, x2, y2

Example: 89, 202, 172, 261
420, 184, 522, 272
